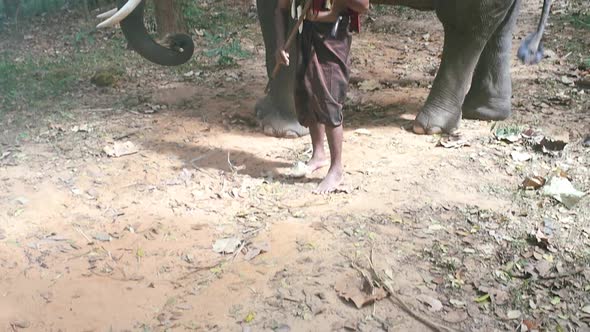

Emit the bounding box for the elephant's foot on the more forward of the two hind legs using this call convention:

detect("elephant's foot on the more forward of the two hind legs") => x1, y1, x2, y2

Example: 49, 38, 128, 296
414, 106, 461, 135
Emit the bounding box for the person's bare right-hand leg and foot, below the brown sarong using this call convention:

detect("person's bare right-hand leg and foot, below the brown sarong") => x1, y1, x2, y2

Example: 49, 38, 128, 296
313, 125, 344, 194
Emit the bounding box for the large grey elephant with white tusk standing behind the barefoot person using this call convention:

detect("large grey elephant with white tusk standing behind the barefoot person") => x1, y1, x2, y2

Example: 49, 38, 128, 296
99, 0, 552, 137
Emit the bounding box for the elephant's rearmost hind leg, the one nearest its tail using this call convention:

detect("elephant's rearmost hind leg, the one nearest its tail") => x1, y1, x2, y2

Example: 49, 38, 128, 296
463, 0, 520, 121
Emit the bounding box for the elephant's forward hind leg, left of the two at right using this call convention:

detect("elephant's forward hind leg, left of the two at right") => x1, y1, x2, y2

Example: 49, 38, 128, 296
414, 0, 514, 134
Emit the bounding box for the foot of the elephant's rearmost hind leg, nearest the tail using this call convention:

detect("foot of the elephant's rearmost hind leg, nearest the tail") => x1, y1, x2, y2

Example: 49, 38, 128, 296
463, 98, 512, 121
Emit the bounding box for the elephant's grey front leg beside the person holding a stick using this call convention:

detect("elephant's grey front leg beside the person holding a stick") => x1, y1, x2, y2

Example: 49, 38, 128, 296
255, 0, 309, 137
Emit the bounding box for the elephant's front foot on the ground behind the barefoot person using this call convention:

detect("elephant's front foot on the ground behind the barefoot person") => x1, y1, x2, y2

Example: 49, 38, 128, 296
255, 97, 309, 138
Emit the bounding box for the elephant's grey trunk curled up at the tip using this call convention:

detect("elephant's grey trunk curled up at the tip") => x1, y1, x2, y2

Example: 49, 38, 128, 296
117, 0, 195, 66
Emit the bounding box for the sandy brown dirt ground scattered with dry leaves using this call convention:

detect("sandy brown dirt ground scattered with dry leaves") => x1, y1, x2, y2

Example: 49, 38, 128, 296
0, 1, 590, 332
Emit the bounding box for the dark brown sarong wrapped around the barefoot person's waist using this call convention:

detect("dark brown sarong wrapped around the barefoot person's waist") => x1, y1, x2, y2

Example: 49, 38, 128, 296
295, 16, 352, 127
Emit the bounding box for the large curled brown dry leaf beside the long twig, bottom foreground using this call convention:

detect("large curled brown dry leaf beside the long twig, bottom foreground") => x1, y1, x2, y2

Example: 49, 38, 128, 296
334, 276, 387, 309
